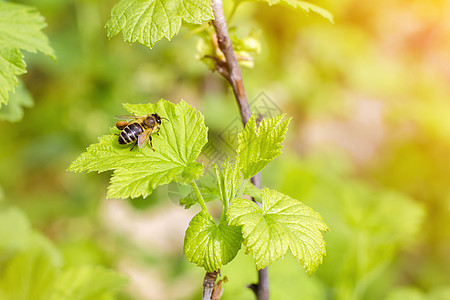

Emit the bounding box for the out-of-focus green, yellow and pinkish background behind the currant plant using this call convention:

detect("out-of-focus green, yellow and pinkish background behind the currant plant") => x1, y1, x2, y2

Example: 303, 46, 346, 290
0, 0, 450, 300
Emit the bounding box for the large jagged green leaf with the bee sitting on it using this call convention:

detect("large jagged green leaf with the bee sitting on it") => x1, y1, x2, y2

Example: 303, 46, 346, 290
69, 100, 207, 198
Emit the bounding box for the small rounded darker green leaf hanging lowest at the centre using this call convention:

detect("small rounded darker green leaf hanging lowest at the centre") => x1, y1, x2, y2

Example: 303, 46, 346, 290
183, 211, 242, 272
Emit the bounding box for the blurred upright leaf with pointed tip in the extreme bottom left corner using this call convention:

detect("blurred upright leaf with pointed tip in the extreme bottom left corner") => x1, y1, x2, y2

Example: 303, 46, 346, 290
0, 233, 62, 300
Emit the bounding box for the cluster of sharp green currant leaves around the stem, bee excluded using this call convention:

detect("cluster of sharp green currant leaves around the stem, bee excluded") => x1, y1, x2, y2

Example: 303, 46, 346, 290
69, 99, 328, 290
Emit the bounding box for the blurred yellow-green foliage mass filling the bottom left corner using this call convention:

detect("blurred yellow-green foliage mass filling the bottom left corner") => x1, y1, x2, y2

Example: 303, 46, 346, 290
0, 208, 126, 300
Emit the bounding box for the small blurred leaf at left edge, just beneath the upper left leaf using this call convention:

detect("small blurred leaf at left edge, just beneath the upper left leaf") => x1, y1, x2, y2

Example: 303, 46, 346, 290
0, 80, 34, 122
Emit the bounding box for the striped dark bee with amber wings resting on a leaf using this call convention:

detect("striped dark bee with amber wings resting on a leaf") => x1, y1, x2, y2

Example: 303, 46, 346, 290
116, 113, 169, 151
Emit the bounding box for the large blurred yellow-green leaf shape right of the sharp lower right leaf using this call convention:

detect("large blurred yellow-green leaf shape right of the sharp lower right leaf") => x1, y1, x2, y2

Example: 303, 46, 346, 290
279, 155, 425, 299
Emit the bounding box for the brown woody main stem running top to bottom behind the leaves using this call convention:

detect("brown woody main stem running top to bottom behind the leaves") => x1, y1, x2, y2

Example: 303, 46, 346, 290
212, 0, 269, 300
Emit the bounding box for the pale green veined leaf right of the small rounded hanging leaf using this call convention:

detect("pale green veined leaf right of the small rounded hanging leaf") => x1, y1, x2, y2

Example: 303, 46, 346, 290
227, 188, 328, 275
